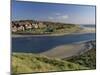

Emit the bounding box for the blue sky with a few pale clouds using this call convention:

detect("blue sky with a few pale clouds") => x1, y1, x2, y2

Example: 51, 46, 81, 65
11, 0, 95, 24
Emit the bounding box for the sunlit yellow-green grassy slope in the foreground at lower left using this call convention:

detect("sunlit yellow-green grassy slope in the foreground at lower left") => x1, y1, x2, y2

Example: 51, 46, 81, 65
12, 53, 89, 74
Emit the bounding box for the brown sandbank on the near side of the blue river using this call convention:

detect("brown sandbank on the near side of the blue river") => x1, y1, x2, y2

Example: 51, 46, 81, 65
40, 42, 92, 59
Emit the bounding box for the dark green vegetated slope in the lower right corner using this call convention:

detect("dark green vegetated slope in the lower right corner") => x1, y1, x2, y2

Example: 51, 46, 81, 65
65, 48, 96, 69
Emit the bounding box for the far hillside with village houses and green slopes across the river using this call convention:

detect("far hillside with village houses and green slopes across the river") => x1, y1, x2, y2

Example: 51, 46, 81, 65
11, 20, 80, 35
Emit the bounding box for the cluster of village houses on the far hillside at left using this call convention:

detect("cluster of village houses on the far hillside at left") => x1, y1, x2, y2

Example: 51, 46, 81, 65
11, 21, 46, 32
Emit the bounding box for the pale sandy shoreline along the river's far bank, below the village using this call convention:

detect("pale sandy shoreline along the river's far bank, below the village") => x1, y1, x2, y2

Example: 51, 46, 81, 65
11, 28, 96, 38
